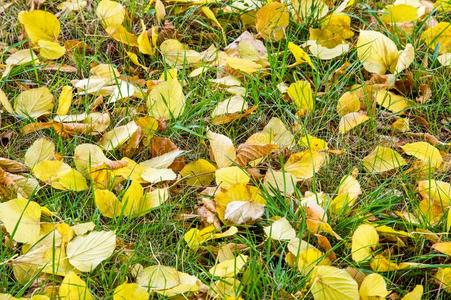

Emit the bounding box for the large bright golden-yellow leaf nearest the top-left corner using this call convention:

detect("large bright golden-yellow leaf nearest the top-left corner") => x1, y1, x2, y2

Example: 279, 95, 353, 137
18, 10, 61, 44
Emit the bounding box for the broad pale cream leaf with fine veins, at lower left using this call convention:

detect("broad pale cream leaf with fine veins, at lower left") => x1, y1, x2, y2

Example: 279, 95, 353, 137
67, 231, 116, 272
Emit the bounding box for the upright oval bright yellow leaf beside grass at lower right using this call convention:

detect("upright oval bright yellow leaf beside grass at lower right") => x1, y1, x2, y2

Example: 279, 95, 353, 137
351, 224, 379, 262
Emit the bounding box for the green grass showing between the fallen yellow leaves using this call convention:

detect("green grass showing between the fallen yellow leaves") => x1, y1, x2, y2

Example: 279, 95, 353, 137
0, 0, 451, 299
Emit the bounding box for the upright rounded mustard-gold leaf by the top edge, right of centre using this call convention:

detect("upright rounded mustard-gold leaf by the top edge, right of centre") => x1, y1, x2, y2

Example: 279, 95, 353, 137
255, 2, 290, 41
